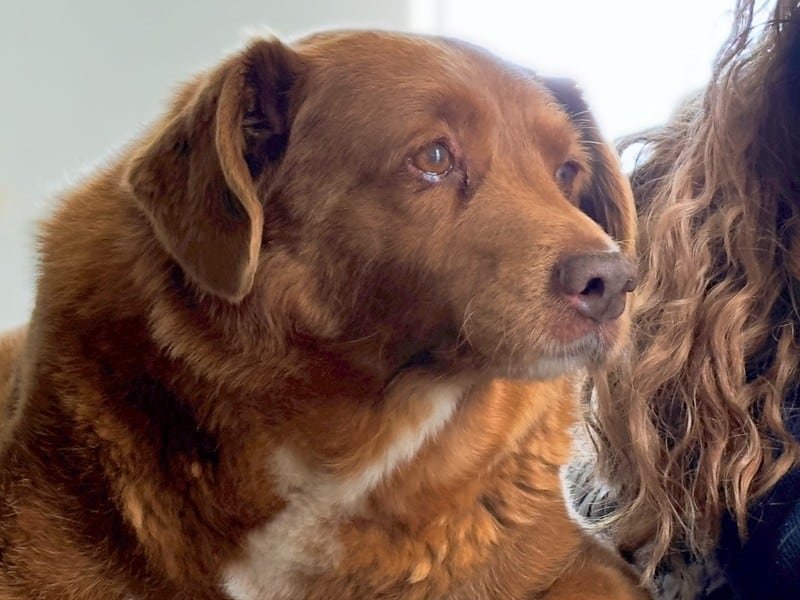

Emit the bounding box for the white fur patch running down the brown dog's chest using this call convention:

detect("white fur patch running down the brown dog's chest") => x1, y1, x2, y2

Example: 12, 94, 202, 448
223, 383, 465, 600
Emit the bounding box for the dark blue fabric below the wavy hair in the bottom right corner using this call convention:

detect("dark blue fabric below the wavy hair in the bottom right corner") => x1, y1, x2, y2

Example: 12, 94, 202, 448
718, 393, 800, 600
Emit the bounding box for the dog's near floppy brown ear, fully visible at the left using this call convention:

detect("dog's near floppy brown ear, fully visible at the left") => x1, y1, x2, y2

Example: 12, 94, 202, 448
125, 40, 300, 302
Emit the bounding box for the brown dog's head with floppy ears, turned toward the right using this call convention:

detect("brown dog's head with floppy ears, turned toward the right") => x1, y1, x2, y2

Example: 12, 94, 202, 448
126, 32, 634, 376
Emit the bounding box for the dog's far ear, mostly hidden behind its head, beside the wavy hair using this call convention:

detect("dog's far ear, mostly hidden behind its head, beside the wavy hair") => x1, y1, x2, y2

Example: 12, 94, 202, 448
543, 78, 636, 256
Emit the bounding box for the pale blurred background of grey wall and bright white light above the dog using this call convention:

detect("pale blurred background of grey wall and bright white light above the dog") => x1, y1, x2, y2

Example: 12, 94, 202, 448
0, 0, 735, 330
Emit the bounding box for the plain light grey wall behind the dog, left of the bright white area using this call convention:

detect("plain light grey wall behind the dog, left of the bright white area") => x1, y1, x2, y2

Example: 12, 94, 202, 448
0, 0, 409, 330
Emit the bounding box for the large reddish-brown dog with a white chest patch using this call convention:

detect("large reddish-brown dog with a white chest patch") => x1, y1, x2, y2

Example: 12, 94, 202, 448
0, 32, 645, 600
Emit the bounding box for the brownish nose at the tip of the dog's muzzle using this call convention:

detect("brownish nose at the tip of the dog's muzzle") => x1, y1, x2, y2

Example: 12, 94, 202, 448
553, 252, 636, 323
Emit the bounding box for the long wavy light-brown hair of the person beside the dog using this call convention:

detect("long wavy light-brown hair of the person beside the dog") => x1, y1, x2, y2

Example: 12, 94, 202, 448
593, 0, 800, 575
